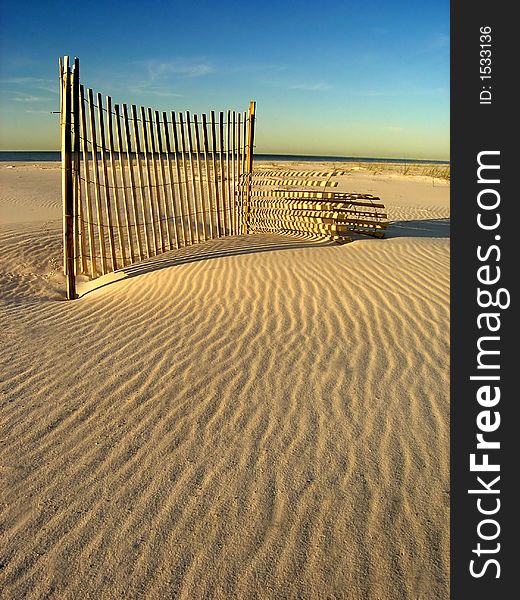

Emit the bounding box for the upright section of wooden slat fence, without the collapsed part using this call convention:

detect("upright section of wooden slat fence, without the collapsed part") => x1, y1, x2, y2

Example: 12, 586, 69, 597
59, 58, 252, 297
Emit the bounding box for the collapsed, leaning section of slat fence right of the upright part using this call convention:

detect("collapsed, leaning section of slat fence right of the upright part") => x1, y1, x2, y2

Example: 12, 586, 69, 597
248, 168, 388, 242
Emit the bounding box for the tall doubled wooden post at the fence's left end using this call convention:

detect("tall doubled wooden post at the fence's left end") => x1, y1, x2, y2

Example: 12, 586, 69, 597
61, 56, 76, 300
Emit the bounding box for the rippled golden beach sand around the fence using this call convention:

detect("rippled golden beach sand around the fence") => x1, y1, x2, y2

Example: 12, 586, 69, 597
0, 164, 449, 600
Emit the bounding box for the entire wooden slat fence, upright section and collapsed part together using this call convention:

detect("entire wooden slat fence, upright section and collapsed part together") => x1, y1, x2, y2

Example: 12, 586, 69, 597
59, 56, 386, 298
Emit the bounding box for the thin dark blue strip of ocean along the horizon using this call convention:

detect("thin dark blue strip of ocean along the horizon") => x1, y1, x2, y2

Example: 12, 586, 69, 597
0, 150, 449, 165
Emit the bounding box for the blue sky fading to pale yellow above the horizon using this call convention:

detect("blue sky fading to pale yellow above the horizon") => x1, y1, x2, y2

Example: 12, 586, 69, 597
0, 0, 449, 159
